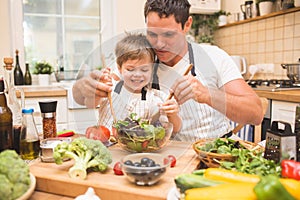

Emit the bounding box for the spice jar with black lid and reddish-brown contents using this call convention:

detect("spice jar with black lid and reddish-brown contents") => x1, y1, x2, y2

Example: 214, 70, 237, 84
39, 101, 57, 139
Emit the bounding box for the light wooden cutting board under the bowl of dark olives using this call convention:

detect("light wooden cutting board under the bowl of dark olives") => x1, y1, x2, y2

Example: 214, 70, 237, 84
30, 141, 199, 200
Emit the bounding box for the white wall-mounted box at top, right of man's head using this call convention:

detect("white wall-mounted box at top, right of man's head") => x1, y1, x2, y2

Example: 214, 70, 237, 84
189, 0, 221, 14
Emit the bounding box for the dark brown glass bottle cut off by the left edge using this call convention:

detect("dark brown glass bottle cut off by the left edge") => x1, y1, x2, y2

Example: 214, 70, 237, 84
0, 78, 13, 152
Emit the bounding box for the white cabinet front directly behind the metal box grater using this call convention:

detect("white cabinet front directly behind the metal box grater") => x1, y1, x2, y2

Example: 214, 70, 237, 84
271, 100, 299, 132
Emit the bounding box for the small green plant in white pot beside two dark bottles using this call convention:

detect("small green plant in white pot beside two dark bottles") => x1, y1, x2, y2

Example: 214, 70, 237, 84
33, 61, 54, 85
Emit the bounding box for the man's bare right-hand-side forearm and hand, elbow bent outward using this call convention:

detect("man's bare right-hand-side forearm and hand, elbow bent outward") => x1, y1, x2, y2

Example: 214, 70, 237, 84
171, 75, 263, 125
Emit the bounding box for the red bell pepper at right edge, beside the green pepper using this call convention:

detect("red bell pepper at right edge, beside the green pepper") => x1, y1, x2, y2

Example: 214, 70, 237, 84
281, 160, 300, 180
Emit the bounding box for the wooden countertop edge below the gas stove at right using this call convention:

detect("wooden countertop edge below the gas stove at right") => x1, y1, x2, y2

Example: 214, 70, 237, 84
255, 90, 300, 103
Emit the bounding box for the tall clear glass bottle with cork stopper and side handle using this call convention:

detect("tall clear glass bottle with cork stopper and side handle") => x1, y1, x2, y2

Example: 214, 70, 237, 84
3, 57, 25, 153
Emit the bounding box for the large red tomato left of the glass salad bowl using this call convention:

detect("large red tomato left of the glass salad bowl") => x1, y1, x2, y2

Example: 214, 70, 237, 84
85, 126, 110, 142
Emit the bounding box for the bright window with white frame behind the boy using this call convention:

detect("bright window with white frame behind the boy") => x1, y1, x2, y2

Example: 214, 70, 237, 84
23, 0, 101, 71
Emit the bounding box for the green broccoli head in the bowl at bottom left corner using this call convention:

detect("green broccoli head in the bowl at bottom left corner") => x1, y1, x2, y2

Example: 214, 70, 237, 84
0, 150, 30, 200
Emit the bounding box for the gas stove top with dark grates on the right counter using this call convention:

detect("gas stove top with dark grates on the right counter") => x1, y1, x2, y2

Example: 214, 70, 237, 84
247, 79, 300, 92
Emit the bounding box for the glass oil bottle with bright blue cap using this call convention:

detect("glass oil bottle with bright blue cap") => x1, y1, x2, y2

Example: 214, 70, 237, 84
20, 108, 40, 160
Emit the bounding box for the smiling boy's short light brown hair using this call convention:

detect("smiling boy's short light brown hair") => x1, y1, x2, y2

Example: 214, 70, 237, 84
115, 33, 155, 68
